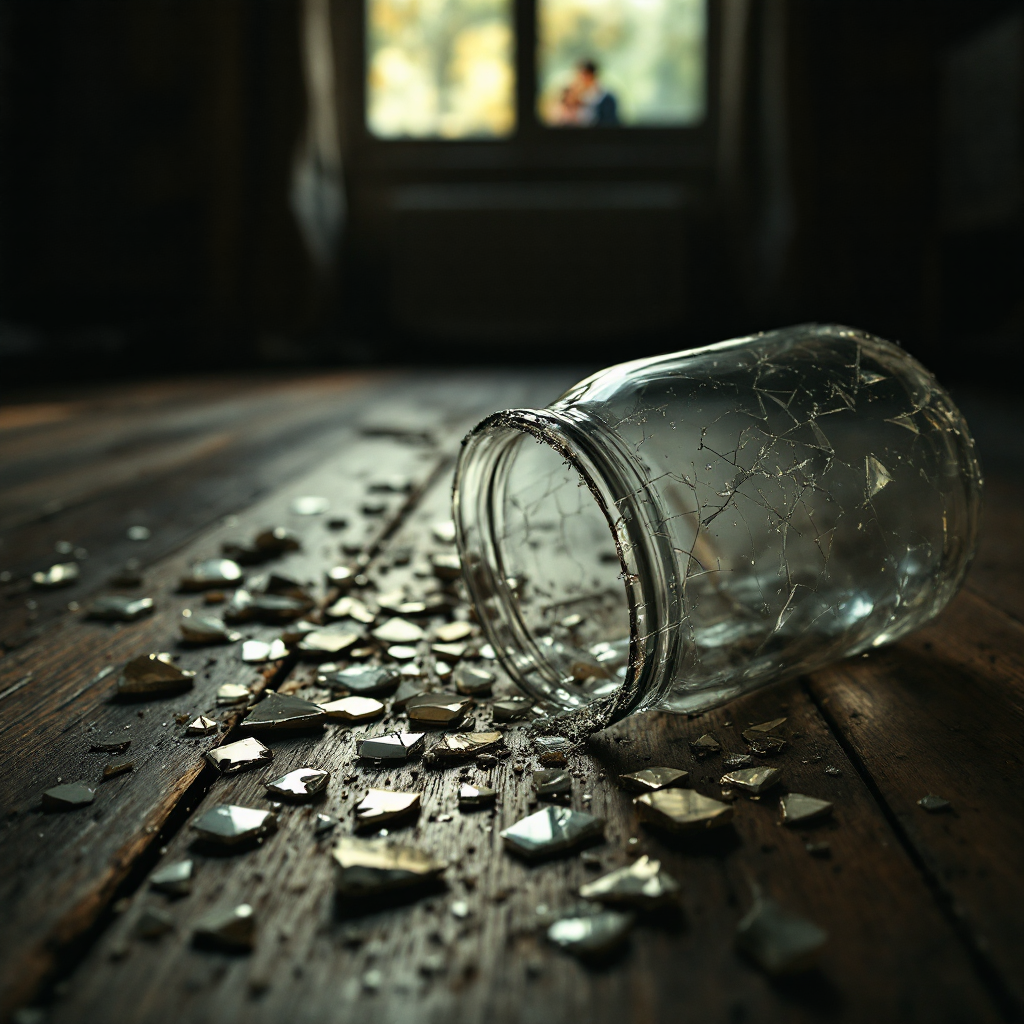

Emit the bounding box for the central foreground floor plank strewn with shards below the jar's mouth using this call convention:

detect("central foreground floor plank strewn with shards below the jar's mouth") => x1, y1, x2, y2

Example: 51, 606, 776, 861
51, 471, 998, 1024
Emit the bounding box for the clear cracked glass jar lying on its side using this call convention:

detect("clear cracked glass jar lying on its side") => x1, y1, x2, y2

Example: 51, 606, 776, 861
454, 325, 982, 727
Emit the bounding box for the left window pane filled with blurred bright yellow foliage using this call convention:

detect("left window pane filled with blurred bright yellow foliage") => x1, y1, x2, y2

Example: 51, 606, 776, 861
367, 0, 515, 138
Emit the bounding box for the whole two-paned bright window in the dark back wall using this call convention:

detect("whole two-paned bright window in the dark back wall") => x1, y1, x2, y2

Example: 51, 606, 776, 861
366, 0, 707, 139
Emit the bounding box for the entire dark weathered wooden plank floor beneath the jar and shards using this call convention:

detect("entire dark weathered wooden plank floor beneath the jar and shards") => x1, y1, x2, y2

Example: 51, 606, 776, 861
0, 371, 1024, 1024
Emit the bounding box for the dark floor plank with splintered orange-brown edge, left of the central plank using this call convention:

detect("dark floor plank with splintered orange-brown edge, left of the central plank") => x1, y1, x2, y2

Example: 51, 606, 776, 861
0, 374, 566, 1013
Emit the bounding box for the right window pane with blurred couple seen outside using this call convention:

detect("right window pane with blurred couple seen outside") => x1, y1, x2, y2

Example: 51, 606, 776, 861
538, 0, 706, 127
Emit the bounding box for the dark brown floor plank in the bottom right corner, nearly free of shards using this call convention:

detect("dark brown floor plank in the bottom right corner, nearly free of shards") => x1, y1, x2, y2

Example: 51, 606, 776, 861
810, 590, 1024, 1014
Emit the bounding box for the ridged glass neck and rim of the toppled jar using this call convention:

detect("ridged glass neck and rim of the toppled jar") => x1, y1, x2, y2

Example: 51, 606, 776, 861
453, 407, 682, 731
